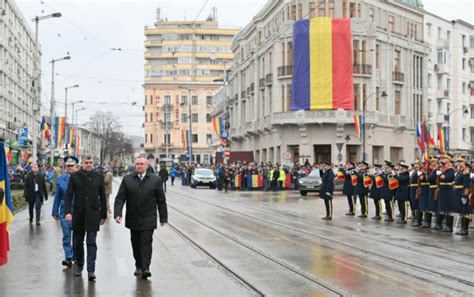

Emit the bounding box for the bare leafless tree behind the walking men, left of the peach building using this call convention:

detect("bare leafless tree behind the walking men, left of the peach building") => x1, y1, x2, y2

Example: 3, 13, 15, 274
86, 111, 122, 163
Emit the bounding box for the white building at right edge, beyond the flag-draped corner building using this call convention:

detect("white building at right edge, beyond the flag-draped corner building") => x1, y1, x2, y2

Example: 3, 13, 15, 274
424, 12, 474, 155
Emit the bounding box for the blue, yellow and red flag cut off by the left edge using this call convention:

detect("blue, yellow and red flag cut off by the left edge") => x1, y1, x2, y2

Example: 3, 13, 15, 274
0, 143, 13, 265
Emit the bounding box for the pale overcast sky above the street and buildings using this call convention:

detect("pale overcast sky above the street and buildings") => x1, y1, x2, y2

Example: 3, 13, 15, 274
16, 0, 474, 135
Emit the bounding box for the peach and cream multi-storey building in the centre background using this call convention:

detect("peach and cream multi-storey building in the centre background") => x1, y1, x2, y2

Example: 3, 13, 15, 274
144, 15, 237, 163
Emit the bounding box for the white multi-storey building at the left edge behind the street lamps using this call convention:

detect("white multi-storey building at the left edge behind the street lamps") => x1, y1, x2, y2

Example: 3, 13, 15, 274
0, 0, 41, 150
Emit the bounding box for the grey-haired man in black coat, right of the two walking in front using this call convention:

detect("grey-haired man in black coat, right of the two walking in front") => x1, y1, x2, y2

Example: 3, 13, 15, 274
114, 156, 168, 279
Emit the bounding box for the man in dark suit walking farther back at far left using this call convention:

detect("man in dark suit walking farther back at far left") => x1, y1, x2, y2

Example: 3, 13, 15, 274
23, 164, 48, 226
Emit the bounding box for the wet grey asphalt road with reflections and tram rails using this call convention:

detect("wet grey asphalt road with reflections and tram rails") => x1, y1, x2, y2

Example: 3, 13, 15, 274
0, 179, 474, 296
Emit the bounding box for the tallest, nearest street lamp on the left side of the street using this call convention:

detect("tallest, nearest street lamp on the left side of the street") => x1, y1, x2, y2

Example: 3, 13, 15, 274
32, 12, 61, 160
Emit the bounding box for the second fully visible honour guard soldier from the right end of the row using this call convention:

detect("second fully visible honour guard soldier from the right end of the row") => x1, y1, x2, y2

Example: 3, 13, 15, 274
438, 153, 455, 232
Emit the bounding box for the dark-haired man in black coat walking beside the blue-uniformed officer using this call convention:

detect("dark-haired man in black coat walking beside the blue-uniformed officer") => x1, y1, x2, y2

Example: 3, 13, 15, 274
64, 156, 107, 281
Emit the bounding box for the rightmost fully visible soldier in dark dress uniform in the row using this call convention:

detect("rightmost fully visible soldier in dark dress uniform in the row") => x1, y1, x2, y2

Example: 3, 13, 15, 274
453, 156, 471, 235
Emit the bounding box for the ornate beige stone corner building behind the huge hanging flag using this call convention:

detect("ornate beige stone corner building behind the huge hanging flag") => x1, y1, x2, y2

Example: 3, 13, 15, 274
222, 0, 428, 163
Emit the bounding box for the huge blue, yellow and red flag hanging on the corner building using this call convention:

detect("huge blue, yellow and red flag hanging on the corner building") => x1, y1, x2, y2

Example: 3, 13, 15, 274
291, 17, 354, 110
